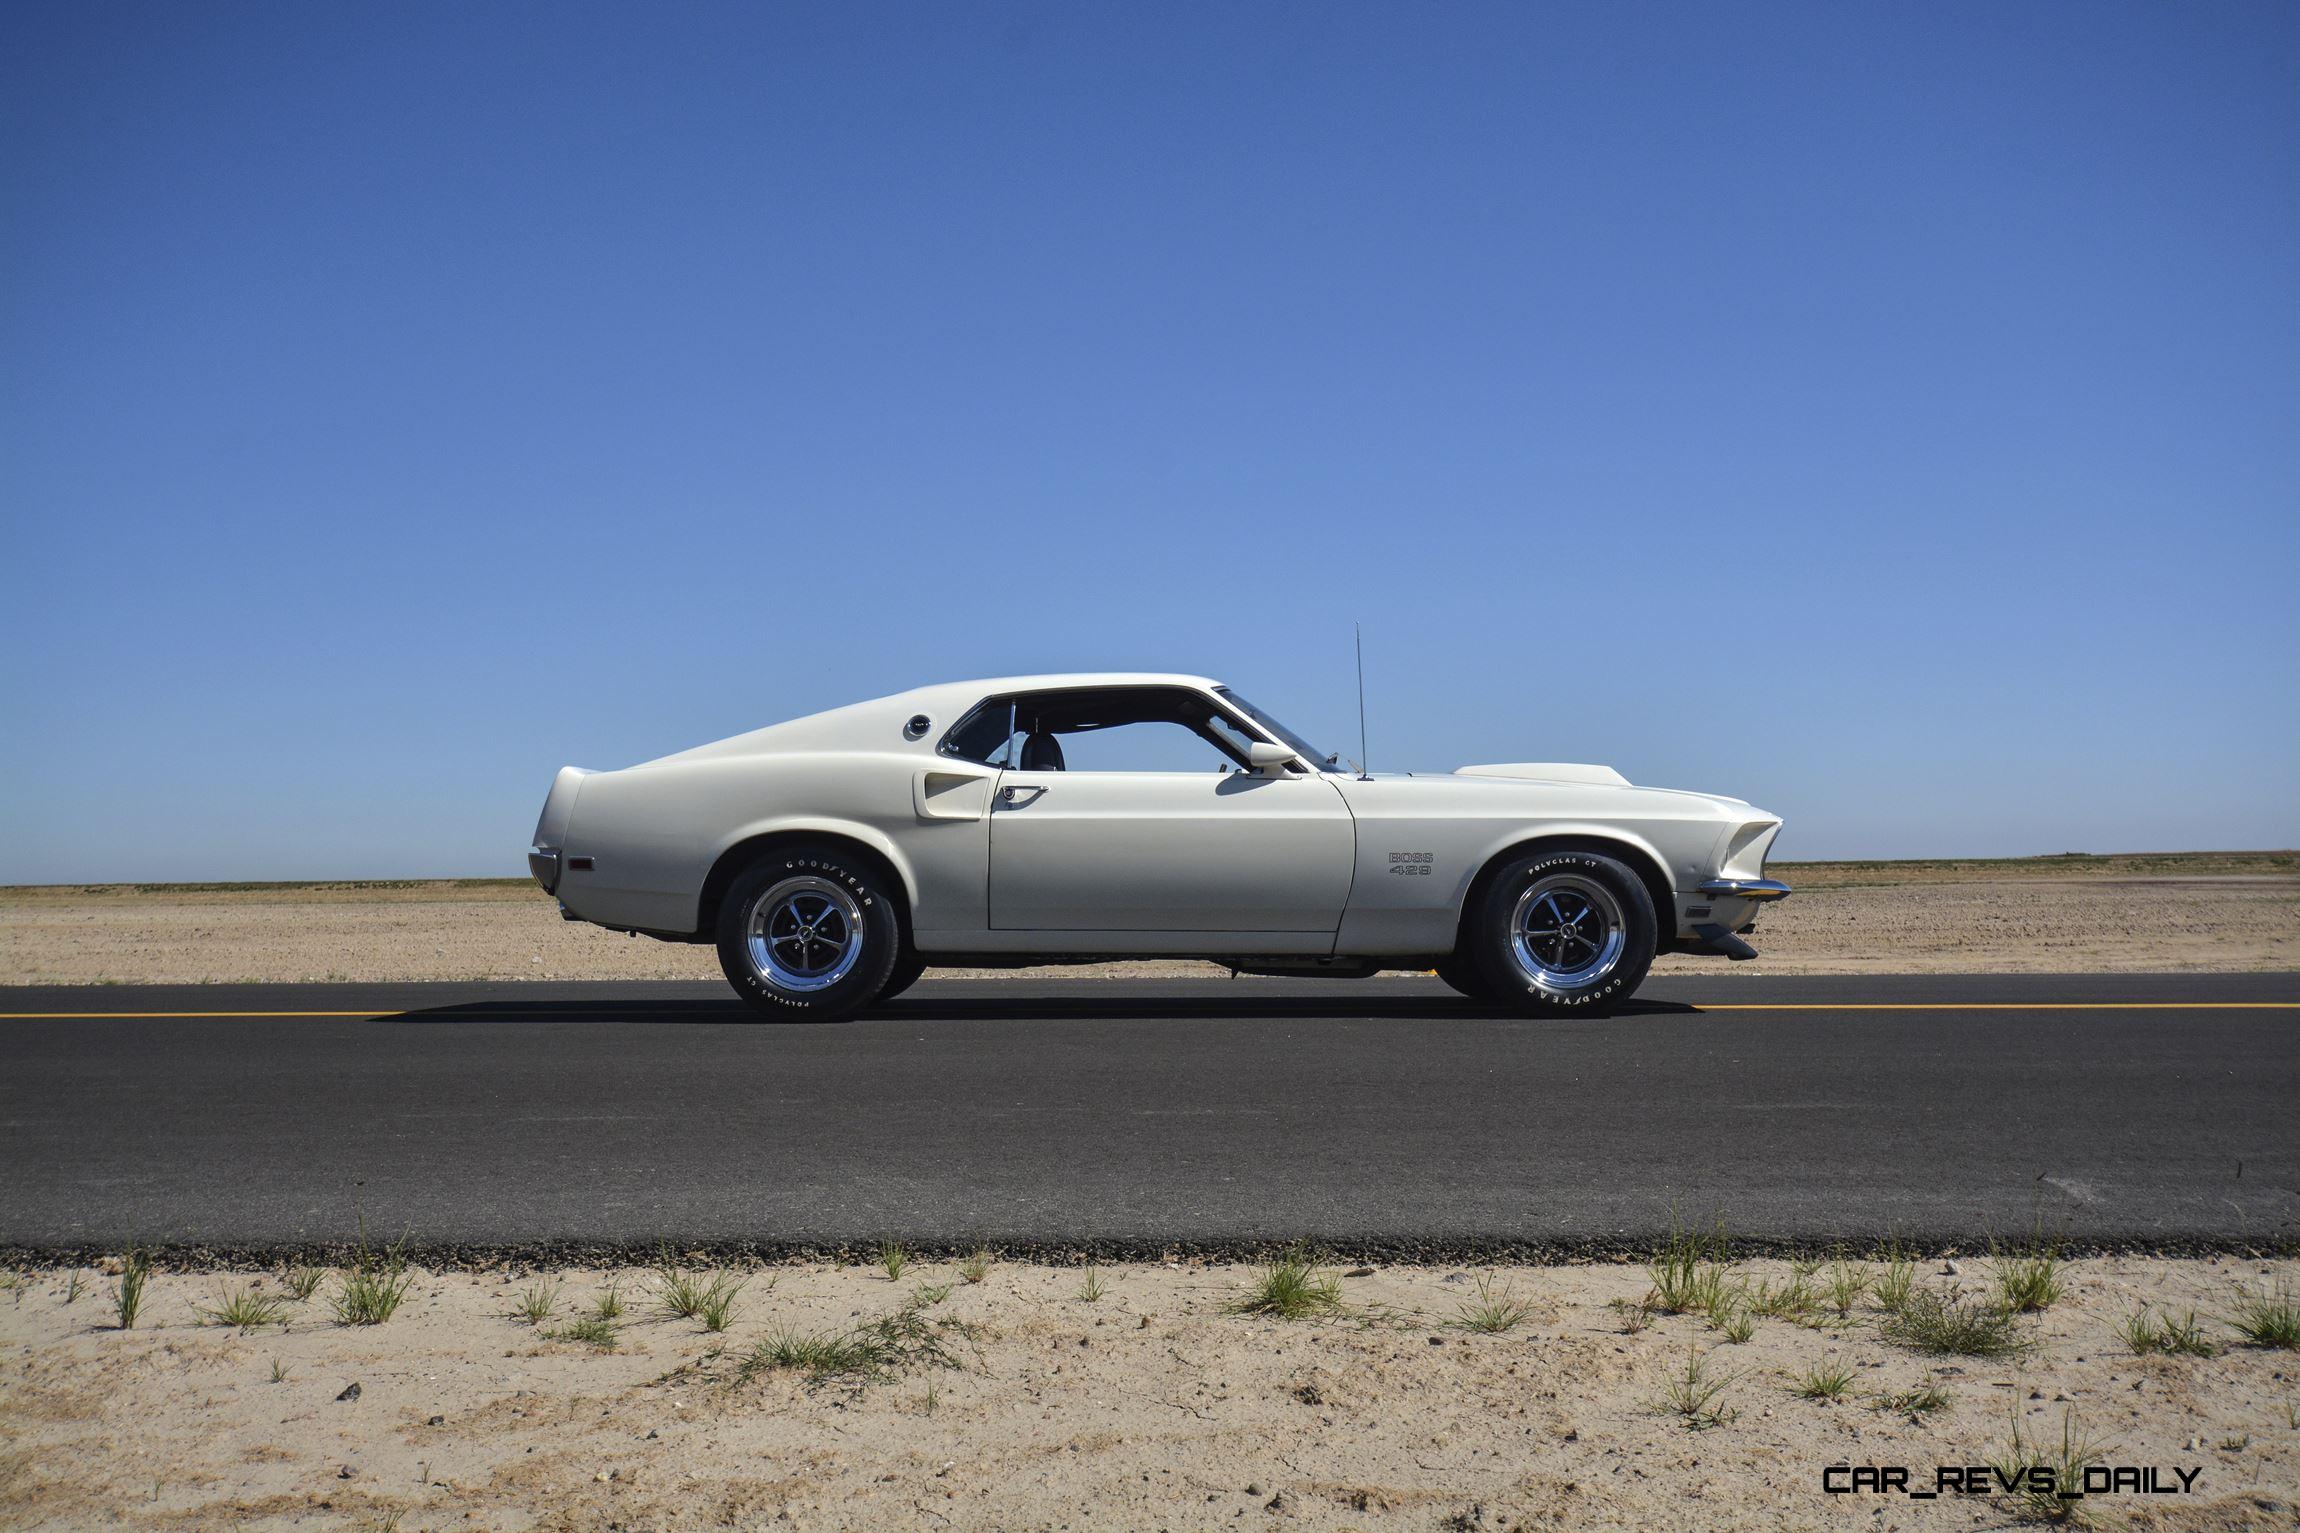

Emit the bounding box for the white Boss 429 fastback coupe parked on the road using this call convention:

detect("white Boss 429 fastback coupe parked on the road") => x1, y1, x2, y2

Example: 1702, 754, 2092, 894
527, 673, 1789, 1020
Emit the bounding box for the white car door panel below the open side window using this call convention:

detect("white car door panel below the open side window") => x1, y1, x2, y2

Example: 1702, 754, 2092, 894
991, 768, 1357, 933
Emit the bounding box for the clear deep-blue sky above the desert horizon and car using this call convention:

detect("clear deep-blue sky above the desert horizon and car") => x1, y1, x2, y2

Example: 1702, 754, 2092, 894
0, 2, 2300, 883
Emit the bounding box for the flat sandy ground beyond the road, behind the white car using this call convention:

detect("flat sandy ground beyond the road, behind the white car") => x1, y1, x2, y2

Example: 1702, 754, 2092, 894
0, 853, 2300, 984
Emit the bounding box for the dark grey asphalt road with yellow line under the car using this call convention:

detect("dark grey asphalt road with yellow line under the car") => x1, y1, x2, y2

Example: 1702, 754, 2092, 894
0, 970, 2300, 1255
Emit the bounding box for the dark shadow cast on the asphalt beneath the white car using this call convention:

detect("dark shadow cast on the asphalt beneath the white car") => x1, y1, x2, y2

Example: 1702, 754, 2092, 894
377, 995, 1697, 1027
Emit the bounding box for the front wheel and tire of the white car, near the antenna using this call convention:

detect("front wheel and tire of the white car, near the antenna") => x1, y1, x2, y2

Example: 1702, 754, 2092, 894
1467, 853, 1656, 1016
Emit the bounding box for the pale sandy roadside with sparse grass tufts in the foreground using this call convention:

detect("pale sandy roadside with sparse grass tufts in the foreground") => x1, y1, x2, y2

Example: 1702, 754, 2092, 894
0, 1257, 2300, 1533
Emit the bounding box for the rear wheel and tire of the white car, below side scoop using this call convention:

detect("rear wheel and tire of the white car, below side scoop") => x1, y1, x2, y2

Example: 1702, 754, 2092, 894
718, 846, 904, 1023
